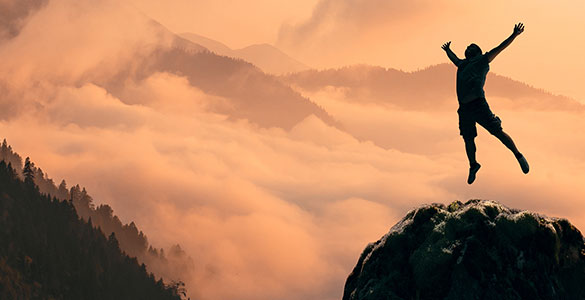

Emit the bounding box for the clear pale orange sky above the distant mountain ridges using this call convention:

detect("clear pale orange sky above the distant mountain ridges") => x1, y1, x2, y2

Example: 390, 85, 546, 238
133, 0, 585, 101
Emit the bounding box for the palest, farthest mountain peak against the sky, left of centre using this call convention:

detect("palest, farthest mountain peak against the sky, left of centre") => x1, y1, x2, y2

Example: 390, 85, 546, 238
180, 33, 309, 75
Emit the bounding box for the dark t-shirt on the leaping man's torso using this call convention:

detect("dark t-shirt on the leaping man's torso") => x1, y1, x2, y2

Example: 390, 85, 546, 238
457, 53, 490, 104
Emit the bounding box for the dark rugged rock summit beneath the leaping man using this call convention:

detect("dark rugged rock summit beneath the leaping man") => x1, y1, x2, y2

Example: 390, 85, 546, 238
343, 200, 585, 300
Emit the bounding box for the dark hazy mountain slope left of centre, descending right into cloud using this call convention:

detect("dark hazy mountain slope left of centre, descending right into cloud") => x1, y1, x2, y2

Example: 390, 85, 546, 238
147, 49, 334, 129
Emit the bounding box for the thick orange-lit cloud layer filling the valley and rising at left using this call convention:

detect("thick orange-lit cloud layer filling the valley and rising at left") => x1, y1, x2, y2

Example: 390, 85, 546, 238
0, 0, 585, 300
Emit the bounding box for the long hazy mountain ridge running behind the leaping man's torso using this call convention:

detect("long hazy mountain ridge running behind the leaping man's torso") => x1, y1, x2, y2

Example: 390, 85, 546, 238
281, 64, 584, 110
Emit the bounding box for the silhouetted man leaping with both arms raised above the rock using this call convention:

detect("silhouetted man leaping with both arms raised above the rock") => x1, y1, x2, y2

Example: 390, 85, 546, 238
441, 23, 529, 184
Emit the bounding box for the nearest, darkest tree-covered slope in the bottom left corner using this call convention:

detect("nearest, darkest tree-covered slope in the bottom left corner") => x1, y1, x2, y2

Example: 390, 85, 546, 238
0, 161, 180, 299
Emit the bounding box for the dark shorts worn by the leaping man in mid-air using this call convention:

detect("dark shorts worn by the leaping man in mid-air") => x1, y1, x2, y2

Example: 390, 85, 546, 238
457, 98, 502, 138
